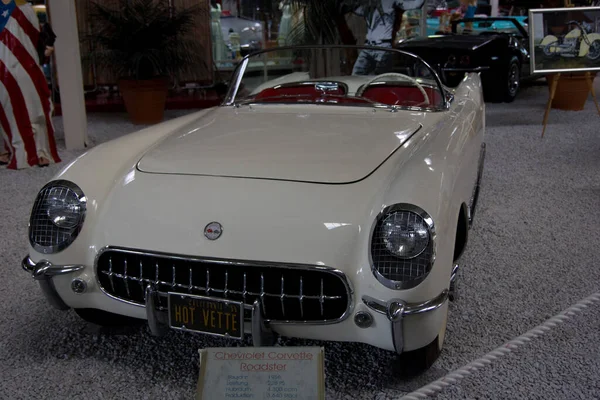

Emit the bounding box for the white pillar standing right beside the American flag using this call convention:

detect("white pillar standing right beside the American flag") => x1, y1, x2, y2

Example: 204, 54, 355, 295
48, 0, 87, 150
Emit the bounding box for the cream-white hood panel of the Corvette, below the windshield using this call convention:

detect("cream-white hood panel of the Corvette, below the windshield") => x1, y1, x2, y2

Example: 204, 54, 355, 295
138, 105, 424, 184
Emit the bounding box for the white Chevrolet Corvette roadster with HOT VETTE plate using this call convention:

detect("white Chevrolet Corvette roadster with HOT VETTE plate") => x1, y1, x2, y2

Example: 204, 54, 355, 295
23, 46, 485, 369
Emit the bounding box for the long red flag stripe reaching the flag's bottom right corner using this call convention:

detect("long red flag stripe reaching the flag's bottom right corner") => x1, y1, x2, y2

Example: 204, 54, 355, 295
0, 30, 60, 162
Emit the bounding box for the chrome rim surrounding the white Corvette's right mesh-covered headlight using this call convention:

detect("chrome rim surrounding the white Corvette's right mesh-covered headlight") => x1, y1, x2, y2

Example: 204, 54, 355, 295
369, 203, 437, 290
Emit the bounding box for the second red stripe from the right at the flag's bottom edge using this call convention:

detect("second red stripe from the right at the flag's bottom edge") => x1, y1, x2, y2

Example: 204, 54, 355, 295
0, 59, 38, 166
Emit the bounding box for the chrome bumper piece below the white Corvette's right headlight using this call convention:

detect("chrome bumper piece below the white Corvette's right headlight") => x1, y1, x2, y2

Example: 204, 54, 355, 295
362, 289, 448, 354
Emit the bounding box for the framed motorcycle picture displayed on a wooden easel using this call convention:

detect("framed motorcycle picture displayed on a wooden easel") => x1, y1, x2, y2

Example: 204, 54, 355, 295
529, 7, 600, 74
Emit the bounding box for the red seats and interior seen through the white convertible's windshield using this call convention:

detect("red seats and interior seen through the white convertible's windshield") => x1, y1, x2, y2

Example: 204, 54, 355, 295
255, 84, 441, 107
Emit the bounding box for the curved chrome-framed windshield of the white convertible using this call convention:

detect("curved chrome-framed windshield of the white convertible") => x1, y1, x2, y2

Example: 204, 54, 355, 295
226, 46, 445, 111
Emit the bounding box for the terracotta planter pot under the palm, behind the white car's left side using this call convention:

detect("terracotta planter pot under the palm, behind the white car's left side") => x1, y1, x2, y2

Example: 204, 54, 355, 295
119, 78, 168, 125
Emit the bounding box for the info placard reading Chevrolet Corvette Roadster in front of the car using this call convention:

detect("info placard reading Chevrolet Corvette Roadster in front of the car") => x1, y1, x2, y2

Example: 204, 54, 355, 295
196, 347, 325, 400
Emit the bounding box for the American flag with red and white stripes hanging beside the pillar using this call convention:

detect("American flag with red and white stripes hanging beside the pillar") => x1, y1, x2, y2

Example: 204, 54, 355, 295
0, 0, 60, 169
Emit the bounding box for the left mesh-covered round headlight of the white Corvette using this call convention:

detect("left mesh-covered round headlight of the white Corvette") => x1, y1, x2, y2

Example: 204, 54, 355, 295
29, 180, 87, 254
